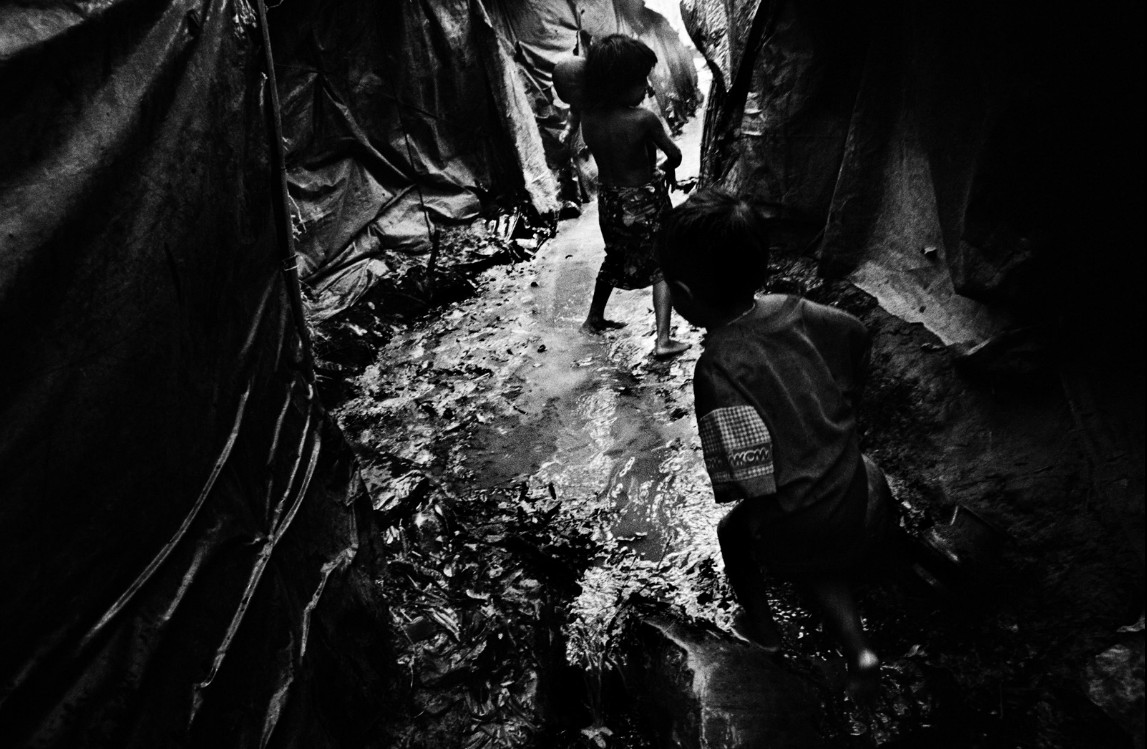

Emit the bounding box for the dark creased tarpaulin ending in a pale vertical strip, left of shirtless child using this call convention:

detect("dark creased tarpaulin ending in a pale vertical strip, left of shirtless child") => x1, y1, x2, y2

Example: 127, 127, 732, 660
264, 0, 557, 317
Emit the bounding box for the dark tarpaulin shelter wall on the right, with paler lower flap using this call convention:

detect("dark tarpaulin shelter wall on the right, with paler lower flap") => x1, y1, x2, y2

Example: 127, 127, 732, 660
682, 0, 1144, 344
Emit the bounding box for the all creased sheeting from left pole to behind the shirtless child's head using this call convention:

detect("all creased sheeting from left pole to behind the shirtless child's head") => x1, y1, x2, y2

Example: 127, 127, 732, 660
277, 0, 697, 318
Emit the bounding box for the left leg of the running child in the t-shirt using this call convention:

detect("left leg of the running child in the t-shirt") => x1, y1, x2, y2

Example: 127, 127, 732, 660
717, 501, 781, 650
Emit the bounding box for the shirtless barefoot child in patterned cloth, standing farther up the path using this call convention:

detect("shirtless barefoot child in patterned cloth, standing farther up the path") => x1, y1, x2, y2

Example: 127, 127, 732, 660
582, 34, 689, 358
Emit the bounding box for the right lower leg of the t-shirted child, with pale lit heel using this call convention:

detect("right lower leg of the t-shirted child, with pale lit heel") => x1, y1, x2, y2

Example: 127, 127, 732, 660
797, 572, 880, 700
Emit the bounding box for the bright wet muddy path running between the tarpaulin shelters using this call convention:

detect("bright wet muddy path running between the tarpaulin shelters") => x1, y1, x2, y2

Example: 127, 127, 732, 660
341, 83, 752, 623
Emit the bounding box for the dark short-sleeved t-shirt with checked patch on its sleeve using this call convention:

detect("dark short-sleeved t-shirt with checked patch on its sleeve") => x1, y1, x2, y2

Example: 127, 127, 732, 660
693, 295, 869, 513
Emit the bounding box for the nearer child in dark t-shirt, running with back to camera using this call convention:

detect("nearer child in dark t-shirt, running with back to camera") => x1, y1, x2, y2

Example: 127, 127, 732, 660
658, 190, 896, 696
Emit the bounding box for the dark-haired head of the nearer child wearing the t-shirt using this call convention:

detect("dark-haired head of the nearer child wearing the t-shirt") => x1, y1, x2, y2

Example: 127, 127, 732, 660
657, 188, 779, 309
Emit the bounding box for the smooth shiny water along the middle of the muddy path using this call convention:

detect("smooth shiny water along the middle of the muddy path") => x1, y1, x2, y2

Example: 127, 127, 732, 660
475, 210, 715, 557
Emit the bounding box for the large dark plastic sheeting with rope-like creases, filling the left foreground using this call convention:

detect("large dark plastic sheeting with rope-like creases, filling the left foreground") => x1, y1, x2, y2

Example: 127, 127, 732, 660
0, 0, 390, 748
